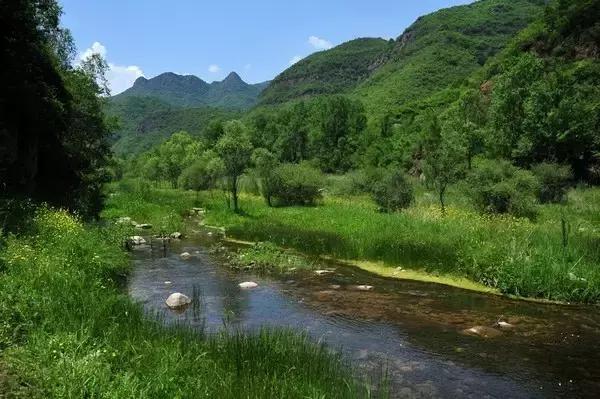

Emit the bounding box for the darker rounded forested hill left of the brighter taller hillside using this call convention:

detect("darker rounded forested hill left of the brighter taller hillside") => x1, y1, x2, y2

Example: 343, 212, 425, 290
260, 39, 392, 104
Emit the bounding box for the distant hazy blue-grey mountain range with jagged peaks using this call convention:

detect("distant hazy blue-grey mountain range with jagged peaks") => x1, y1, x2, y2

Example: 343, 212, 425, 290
111, 72, 268, 109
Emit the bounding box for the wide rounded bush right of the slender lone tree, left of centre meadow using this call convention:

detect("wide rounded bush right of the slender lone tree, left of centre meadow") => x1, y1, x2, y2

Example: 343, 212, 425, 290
264, 163, 323, 206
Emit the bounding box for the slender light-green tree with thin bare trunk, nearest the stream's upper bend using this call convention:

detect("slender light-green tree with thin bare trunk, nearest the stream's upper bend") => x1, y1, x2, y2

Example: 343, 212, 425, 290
215, 120, 252, 212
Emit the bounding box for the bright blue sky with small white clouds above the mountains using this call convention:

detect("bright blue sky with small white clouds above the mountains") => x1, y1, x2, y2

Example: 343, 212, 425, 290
61, 0, 471, 94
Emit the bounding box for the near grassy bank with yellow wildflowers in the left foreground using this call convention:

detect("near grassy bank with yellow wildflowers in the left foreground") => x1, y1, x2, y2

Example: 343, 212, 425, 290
0, 205, 376, 398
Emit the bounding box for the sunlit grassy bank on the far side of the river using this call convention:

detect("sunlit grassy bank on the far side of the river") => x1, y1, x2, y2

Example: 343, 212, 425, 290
103, 181, 600, 303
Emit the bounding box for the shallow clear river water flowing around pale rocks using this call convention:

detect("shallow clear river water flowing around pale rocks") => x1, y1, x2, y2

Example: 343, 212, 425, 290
128, 234, 600, 398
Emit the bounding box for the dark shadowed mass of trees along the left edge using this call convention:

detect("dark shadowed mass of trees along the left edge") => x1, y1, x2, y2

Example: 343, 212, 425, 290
0, 0, 109, 218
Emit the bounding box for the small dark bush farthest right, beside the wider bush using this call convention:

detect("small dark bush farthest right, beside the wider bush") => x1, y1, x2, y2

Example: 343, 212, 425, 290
531, 163, 573, 204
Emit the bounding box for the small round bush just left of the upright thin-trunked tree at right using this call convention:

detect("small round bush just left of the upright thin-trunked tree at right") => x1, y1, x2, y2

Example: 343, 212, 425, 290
371, 171, 415, 212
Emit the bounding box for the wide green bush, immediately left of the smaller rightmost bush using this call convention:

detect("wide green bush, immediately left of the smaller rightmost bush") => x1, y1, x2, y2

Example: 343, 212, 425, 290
468, 160, 539, 219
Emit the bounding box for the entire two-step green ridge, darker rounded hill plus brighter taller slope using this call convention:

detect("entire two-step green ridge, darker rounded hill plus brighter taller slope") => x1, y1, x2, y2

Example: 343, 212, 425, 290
261, 0, 546, 114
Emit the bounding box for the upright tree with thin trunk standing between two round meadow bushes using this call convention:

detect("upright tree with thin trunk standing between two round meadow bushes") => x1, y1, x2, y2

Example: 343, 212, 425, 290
423, 113, 465, 213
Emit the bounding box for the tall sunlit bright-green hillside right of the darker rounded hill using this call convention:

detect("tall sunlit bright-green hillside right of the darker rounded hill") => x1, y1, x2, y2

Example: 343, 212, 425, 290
355, 0, 545, 117
